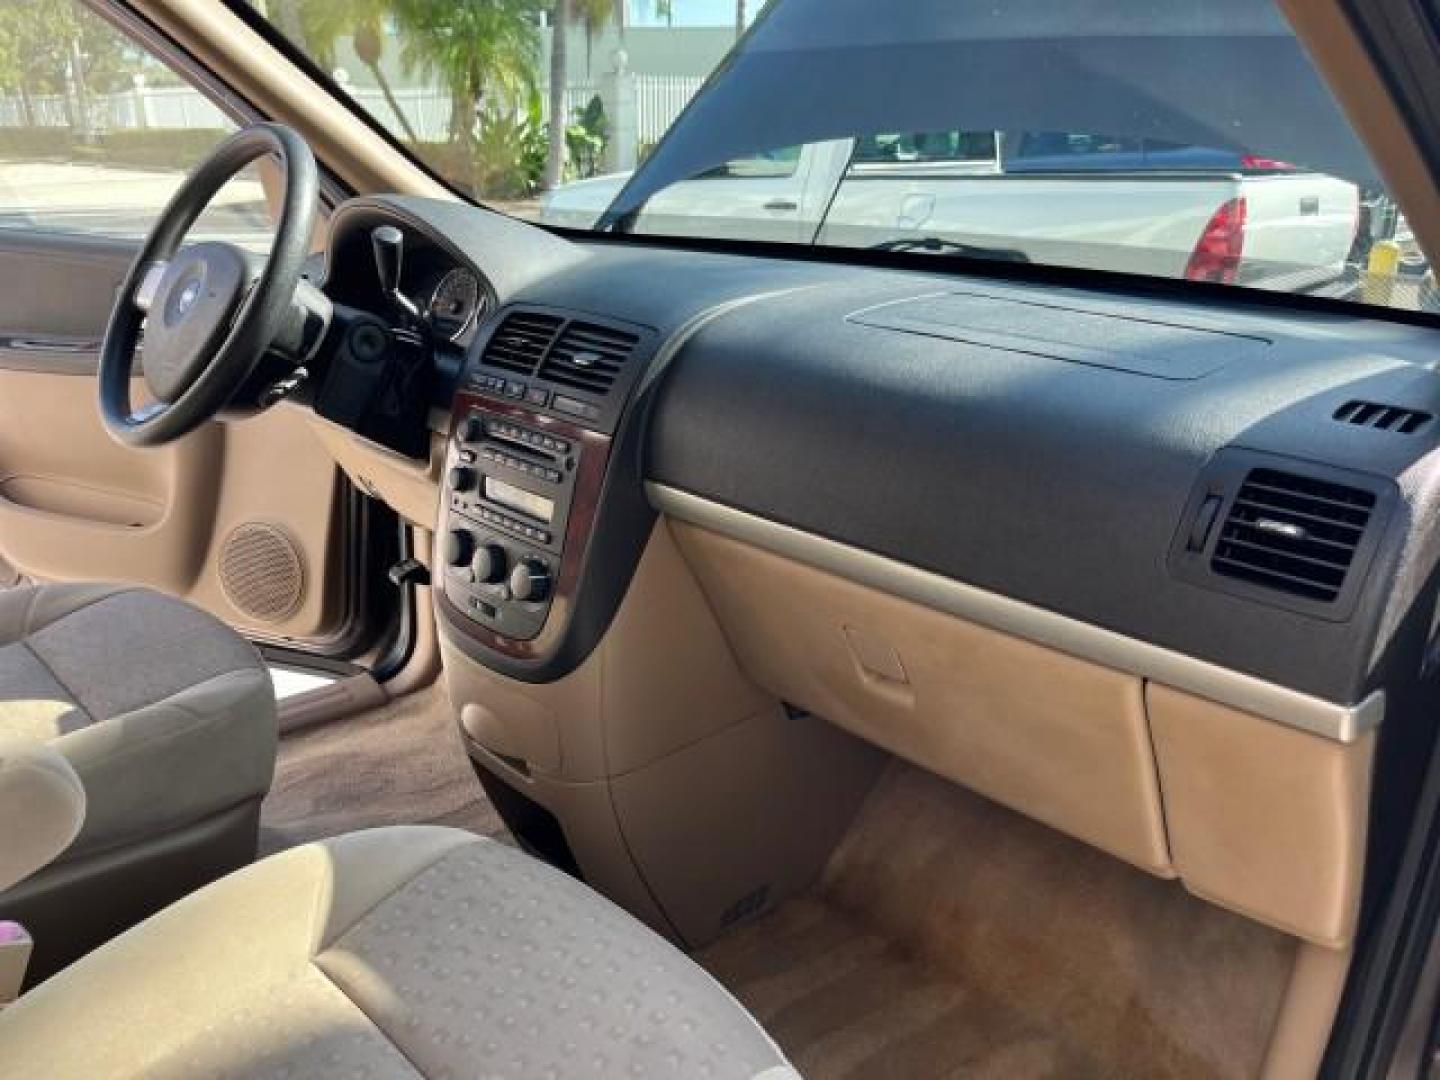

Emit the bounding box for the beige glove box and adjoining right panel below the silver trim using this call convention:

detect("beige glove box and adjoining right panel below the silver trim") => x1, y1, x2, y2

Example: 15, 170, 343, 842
652, 490, 1374, 948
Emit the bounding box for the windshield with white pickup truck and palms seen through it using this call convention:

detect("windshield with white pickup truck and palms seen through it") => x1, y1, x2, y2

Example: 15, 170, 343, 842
251, 0, 1440, 311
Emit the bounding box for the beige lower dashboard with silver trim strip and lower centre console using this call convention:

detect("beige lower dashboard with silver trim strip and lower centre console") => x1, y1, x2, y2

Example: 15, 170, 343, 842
442, 487, 1384, 949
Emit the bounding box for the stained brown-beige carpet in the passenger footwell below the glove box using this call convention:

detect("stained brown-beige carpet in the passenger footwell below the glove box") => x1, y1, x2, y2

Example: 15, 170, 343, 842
698, 766, 1295, 1080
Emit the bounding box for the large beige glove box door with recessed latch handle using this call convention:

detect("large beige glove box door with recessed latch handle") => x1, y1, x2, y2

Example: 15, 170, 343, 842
672, 523, 1174, 877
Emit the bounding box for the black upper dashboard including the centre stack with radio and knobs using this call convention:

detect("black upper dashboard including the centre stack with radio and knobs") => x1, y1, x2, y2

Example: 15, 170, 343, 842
321, 199, 1440, 714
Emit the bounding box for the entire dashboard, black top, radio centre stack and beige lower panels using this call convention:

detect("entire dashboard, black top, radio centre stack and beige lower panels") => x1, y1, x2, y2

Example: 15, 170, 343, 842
306, 197, 1440, 946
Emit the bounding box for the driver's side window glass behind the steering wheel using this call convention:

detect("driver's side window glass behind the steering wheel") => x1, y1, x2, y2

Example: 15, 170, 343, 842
0, 0, 272, 249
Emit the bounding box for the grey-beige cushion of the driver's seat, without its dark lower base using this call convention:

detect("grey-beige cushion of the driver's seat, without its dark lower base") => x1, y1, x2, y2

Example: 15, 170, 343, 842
0, 585, 276, 858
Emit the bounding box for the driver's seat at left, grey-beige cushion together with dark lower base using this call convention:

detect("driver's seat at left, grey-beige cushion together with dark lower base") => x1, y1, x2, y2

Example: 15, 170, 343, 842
0, 585, 276, 976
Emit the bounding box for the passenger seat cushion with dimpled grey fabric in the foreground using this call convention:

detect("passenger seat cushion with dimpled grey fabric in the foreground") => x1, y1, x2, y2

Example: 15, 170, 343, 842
0, 827, 795, 1080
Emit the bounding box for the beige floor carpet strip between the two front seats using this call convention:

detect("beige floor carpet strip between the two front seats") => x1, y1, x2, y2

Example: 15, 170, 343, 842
261, 685, 507, 854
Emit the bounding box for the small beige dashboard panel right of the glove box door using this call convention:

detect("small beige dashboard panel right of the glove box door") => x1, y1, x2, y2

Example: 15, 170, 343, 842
1146, 683, 1375, 948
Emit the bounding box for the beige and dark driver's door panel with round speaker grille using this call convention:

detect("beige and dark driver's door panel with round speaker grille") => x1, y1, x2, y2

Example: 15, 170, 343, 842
0, 230, 347, 645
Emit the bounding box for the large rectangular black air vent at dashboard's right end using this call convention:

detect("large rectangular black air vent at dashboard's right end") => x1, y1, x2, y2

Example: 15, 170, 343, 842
1210, 468, 1375, 603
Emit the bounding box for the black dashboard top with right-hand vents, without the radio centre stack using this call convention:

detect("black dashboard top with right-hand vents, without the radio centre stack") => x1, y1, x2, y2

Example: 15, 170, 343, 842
331, 199, 1440, 704
